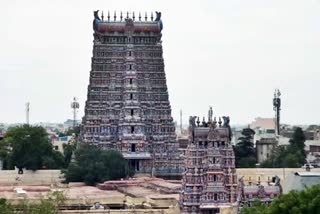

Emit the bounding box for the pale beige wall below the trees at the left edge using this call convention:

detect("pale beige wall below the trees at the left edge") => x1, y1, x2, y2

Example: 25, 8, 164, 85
0, 170, 63, 186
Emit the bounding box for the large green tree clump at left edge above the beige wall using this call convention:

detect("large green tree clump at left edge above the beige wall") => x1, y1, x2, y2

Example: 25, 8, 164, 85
0, 125, 64, 170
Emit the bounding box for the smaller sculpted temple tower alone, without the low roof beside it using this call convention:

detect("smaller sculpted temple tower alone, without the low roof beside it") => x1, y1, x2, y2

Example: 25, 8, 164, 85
180, 108, 237, 213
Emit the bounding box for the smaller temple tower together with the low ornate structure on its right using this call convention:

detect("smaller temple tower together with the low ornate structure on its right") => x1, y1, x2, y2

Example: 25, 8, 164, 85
180, 108, 282, 214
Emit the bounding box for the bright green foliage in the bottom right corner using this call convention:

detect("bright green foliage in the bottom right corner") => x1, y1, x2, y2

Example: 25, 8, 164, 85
241, 185, 320, 214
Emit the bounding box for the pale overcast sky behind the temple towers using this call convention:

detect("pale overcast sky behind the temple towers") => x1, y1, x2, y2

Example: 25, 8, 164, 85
0, 0, 320, 124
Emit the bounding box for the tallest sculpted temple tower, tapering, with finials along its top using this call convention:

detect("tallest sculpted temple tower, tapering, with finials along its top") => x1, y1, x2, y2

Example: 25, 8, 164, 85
81, 11, 181, 174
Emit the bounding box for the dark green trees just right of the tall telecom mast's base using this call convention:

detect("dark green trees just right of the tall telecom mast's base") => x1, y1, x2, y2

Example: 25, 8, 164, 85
261, 127, 306, 168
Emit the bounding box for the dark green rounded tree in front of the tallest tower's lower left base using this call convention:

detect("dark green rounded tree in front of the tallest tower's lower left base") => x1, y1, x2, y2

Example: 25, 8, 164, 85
63, 145, 133, 185
